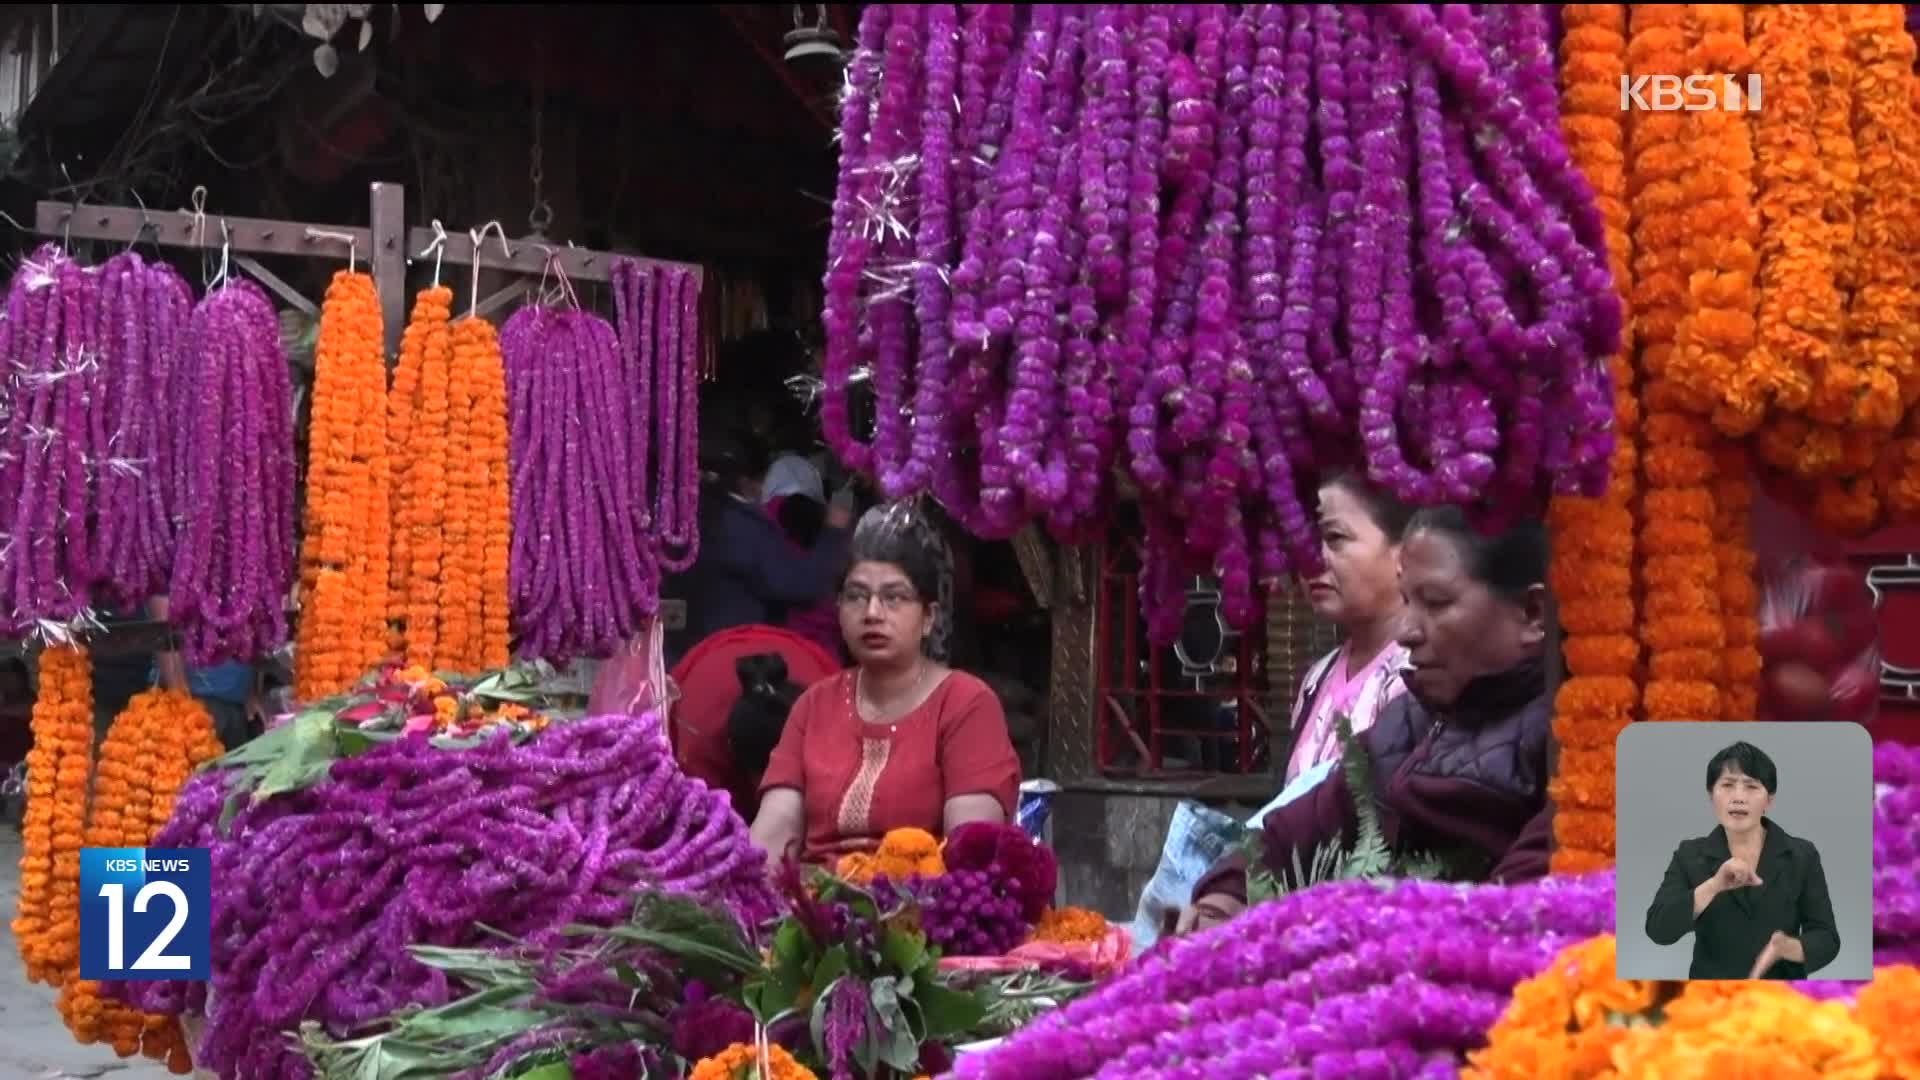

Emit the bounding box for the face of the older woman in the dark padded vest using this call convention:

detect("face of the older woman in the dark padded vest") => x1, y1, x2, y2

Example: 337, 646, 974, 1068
1400, 530, 1546, 707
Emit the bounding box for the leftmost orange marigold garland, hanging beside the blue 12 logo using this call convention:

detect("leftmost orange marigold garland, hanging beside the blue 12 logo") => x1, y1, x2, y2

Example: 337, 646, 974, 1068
12, 646, 94, 986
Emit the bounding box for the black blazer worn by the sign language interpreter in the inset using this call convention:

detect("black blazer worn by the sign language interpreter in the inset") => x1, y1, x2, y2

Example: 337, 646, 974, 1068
1647, 817, 1839, 978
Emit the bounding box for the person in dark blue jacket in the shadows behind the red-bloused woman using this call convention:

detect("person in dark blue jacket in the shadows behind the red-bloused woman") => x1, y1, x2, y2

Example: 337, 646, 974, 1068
662, 430, 852, 665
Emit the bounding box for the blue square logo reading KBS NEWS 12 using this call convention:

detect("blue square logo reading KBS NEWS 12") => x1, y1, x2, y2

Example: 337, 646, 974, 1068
81, 847, 213, 982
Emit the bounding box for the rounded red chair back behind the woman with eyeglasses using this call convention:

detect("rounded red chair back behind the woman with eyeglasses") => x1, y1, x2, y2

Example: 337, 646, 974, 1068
668, 626, 841, 822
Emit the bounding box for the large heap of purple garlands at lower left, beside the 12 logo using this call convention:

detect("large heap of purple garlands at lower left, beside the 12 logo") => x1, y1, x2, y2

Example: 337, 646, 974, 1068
109, 715, 778, 1080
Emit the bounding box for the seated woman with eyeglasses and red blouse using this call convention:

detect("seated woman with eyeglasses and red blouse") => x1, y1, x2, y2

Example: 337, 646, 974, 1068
753, 505, 1020, 867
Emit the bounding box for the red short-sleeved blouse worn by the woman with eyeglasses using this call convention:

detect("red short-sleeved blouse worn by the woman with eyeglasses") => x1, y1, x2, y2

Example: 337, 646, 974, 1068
760, 671, 1020, 861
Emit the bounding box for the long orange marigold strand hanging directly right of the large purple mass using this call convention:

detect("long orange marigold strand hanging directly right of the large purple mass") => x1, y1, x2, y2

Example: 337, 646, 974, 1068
1548, 4, 1640, 871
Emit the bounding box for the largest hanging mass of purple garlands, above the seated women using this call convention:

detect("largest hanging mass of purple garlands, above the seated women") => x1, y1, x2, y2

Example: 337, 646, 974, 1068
822, 4, 1622, 640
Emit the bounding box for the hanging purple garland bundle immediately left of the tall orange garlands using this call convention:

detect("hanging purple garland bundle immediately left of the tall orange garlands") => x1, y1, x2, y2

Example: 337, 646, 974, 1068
169, 281, 296, 667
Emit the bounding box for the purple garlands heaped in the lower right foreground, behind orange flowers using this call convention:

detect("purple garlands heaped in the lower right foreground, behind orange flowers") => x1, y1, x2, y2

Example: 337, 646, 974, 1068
952, 744, 1920, 1080
